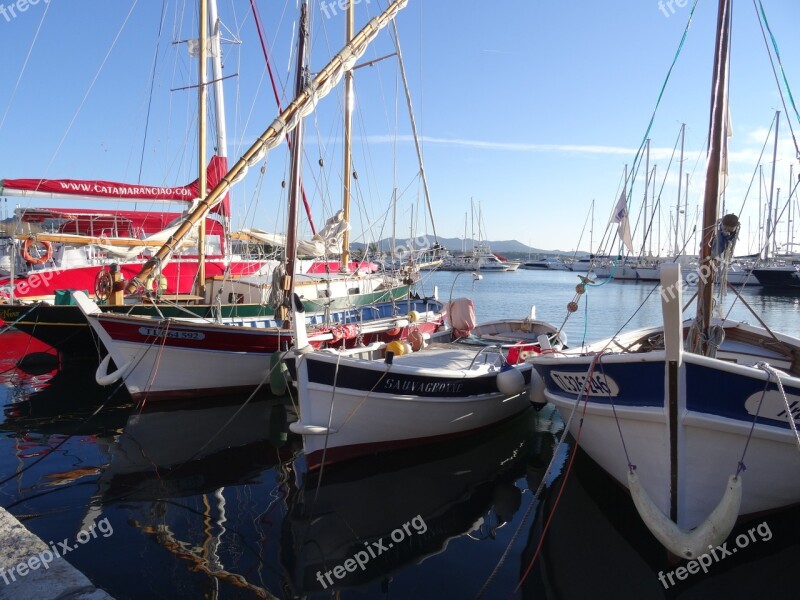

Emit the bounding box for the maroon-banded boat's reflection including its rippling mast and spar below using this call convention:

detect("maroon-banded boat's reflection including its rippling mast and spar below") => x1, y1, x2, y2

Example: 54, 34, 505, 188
80, 396, 301, 598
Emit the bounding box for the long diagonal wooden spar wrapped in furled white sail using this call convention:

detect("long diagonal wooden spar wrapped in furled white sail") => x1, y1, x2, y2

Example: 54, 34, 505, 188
125, 0, 408, 294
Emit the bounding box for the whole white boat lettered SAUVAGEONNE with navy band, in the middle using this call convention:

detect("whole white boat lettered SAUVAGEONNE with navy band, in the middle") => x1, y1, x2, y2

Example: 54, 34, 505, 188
282, 3, 564, 470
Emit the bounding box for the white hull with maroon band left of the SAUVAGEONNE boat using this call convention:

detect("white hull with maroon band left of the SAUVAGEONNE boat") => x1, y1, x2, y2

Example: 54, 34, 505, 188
78, 300, 441, 401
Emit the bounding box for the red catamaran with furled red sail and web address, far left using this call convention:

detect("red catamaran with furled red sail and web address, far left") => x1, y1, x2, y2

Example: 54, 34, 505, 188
0, 2, 264, 304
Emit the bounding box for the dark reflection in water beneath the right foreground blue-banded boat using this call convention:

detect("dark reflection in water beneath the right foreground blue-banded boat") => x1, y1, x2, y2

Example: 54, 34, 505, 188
522, 451, 800, 600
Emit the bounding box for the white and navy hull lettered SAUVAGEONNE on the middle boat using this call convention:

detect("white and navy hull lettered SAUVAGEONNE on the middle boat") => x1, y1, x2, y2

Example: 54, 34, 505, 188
291, 350, 531, 470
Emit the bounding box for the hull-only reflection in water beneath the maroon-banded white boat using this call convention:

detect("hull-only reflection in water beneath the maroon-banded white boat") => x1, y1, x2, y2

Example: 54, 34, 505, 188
87, 396, 295, 507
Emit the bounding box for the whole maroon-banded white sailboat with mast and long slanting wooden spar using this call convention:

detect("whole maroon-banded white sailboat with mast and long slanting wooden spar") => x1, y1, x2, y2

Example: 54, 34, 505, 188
73, 0, 444, 400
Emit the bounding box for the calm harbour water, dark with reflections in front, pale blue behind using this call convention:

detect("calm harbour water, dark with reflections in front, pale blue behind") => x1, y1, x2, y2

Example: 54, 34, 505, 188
0, 271, 800, 599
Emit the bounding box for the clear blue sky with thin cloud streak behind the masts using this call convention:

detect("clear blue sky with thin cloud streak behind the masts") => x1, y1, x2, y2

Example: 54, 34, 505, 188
0, 0, 800, 250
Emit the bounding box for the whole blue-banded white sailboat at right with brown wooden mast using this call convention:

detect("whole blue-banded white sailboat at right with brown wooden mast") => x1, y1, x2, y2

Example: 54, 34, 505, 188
530, 0, 800, 559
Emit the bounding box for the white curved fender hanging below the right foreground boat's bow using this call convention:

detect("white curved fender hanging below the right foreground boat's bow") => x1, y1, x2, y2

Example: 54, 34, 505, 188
628, 470, 742, 559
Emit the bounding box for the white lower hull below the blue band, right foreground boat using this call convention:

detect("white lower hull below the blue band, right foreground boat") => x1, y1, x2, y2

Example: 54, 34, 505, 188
547, 393, 800, 529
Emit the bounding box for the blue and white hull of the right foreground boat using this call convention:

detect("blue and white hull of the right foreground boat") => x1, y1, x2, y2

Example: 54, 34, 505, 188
535, 352, 800, 529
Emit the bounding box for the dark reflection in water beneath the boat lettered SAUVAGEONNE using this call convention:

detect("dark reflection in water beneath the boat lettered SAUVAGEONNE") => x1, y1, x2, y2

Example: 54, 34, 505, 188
281, 409, 554, 597
